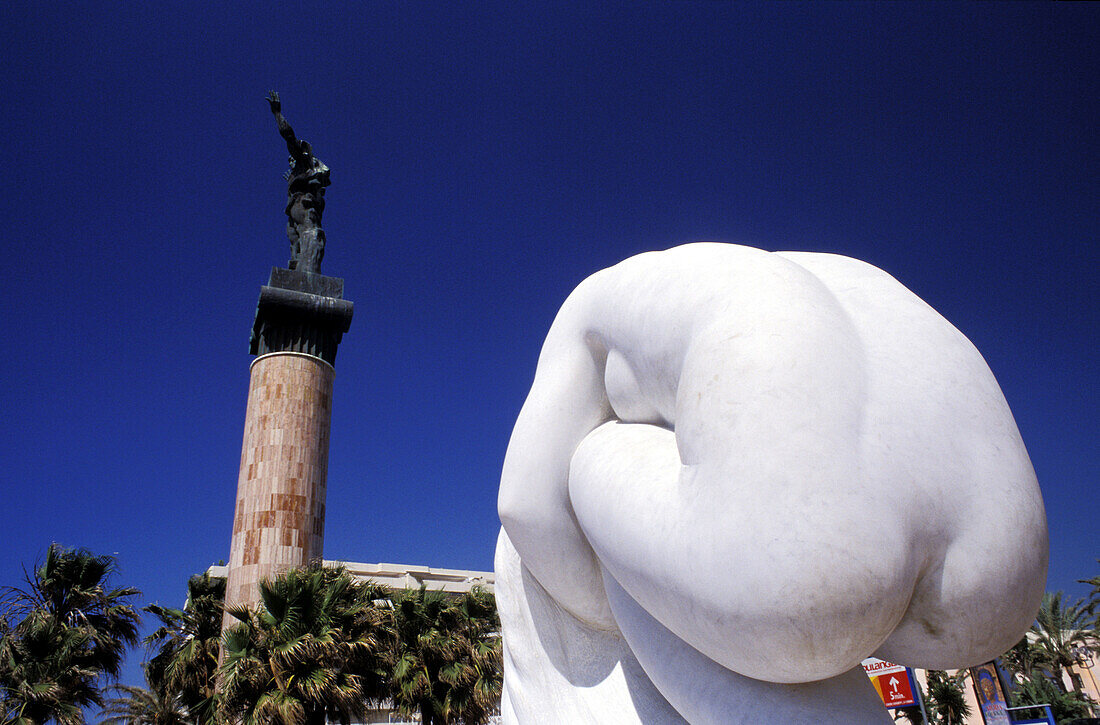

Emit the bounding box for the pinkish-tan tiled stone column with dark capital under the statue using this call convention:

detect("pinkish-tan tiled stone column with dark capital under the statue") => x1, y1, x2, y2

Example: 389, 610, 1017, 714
226, 268, 352, 620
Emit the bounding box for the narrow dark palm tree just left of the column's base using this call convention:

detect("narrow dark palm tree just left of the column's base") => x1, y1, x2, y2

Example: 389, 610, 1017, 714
145, 574, 226, 725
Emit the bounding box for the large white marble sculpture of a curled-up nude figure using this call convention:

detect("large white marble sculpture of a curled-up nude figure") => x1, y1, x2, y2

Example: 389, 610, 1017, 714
496, 243, 1047, 725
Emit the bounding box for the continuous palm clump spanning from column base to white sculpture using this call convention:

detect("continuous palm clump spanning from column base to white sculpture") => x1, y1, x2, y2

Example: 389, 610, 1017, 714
211, 568, 502, 725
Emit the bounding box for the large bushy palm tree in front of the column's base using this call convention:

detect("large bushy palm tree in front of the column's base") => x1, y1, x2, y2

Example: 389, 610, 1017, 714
219, 567, 392, 725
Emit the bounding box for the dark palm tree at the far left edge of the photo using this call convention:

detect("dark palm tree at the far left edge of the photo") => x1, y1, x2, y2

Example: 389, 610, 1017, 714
0, 545, 141, 725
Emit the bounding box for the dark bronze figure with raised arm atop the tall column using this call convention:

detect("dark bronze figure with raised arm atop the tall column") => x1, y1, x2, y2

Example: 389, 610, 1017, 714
267, 90, 331, 274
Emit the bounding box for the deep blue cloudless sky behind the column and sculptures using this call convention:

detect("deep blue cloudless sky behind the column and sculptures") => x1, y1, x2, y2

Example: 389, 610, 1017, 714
0, 2, 1100, 686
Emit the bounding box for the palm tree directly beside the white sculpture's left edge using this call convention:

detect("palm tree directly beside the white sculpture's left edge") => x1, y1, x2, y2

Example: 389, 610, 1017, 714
392, 586, 502, 725
